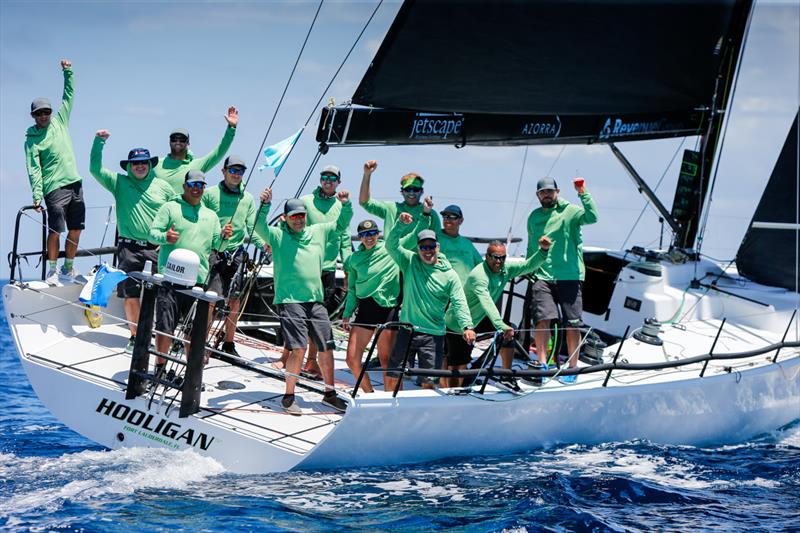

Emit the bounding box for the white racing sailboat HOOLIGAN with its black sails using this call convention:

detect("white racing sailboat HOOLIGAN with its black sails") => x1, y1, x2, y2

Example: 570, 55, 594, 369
3, 1, 800, 473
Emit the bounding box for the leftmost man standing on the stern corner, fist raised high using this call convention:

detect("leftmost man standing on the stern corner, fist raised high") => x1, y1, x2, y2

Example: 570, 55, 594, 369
25, 59, 86, 285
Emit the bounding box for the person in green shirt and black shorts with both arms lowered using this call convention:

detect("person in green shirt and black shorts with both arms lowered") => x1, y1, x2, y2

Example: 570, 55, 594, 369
342, 220, 400, 392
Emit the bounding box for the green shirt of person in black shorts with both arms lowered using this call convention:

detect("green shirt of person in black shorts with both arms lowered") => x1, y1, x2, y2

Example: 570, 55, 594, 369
342, 241, 400, 318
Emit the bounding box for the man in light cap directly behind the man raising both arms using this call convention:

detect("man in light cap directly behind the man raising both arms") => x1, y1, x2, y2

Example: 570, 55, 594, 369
300, 165, 353, 375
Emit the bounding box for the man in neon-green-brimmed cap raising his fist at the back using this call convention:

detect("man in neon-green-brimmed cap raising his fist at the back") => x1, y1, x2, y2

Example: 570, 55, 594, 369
358, 160, 442, 248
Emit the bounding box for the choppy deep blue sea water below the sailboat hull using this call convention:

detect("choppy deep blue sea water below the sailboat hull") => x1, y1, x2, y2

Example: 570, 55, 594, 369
0, 288, 800, 532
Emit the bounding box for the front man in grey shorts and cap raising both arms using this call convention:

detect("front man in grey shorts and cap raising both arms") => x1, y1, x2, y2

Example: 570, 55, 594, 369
255, 189, 353, 415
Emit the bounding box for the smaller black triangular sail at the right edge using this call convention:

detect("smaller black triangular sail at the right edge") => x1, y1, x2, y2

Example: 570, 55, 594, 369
736, 111, 800, 291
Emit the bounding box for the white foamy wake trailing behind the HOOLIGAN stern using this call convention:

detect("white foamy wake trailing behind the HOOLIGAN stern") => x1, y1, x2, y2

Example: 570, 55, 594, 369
0, 448, 224, 516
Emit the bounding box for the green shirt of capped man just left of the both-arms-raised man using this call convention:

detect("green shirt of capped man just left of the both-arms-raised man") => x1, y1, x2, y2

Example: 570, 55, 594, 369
201, 181, 264, 252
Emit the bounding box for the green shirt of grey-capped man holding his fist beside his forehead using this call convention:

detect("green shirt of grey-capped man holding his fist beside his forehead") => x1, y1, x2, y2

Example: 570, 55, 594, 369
386, 216, 472, 335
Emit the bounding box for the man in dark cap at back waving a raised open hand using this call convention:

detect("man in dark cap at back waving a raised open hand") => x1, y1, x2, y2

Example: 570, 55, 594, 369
155, 106, 239, 195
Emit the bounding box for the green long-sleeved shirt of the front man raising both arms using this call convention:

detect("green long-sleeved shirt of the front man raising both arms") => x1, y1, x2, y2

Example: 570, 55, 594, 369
255, 200, 353, 305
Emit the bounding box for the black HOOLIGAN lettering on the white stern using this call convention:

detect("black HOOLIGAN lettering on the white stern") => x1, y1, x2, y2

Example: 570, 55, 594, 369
95, 398, 214, 450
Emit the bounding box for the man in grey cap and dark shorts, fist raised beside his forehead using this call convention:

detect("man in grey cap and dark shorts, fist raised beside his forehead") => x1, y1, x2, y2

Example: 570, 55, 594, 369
385, 212, 475, 390
